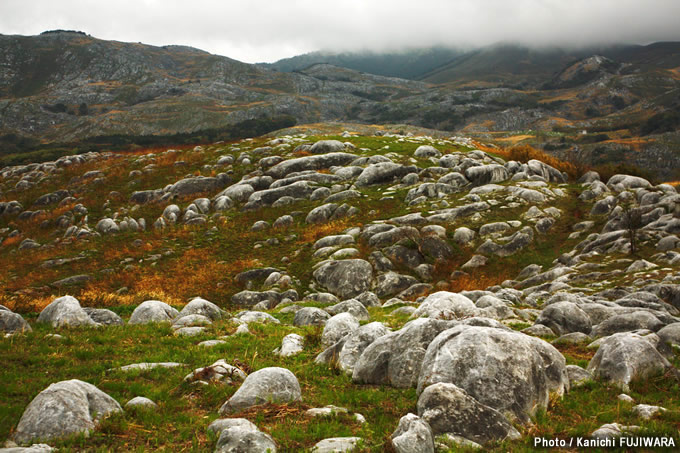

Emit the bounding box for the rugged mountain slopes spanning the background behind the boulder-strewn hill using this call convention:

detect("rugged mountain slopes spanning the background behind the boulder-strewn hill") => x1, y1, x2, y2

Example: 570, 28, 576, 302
0, 31, 680, 174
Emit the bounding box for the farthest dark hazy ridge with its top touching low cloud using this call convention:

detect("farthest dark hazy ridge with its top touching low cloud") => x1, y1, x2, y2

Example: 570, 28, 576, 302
261, 42, 680, 88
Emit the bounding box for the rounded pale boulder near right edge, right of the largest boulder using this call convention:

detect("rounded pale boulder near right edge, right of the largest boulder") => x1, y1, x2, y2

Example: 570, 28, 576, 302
588, 332, 671, 391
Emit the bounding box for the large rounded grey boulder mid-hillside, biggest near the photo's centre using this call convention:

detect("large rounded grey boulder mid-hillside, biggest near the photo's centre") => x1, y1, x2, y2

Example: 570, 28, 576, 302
313, 259, 373, 299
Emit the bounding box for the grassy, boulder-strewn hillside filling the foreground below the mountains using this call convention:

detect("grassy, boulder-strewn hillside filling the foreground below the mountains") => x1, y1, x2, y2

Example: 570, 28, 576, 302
0, 122, 680, 452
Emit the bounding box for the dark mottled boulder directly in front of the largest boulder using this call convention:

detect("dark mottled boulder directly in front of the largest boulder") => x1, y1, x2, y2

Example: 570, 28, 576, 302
418, 383, 520, 445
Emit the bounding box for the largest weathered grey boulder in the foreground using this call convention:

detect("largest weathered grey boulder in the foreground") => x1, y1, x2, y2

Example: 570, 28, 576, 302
418, 325, 569, 422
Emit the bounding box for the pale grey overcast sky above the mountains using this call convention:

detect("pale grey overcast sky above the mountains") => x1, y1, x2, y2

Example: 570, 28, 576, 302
0, 0, 680, 63
